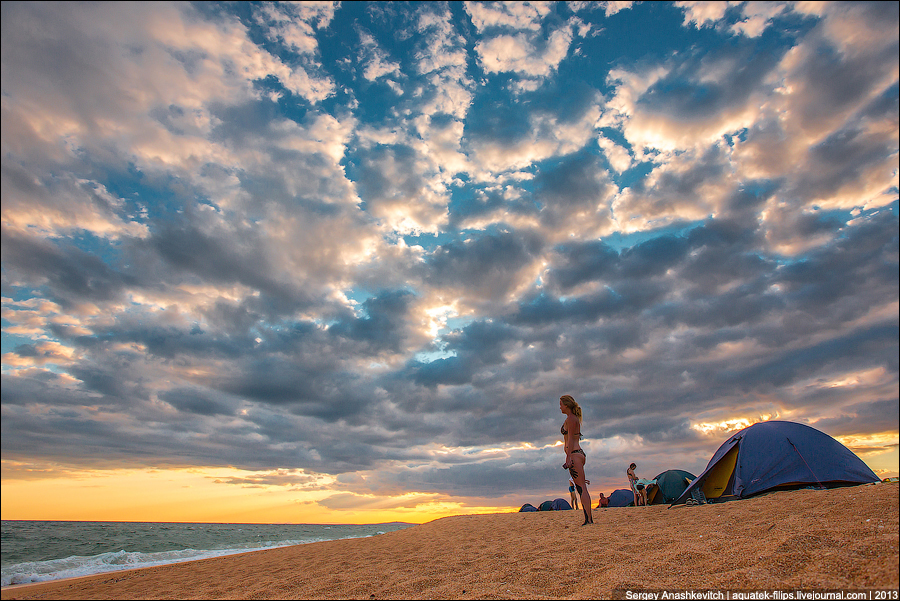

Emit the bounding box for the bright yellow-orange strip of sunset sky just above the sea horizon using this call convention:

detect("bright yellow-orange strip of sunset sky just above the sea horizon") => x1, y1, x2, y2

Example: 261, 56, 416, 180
2, 462, 510, 524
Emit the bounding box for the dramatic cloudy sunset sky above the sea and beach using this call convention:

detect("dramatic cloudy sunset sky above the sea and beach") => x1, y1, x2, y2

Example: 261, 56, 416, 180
2, 1, 898, 522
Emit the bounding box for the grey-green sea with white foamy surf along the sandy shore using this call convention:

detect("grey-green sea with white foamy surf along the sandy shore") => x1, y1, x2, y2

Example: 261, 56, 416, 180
0, 520, 414, 586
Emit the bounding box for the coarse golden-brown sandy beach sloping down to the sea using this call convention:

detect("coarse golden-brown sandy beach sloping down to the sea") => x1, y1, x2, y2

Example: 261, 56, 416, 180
2, 484, 900, 599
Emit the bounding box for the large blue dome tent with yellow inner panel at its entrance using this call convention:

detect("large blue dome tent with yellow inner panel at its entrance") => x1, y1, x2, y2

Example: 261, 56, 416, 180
672, 421, 878, 505
